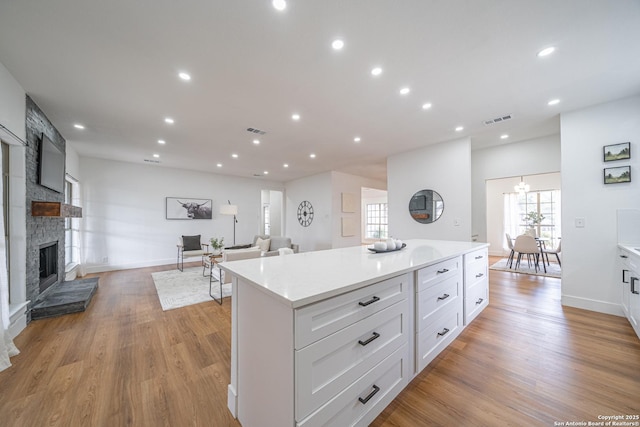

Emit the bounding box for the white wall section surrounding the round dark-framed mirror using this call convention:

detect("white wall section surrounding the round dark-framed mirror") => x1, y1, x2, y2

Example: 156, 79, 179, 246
387, 138, 471, 241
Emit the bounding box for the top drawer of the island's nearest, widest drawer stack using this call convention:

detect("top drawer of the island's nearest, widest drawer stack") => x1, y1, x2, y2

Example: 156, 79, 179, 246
295, 274, 410, 350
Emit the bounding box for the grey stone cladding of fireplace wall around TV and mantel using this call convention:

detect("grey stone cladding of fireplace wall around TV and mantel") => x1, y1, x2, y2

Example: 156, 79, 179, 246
25, 96, 66, 322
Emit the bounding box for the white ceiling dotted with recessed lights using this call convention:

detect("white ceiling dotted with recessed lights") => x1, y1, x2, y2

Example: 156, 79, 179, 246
0, 0, 640, 181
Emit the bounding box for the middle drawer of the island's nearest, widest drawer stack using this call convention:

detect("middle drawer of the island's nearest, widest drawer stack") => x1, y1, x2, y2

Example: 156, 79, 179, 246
295, 300, 408, 420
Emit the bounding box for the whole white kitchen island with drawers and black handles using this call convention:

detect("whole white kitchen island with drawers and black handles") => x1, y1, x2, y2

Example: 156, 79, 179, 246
220, 240, 489, 427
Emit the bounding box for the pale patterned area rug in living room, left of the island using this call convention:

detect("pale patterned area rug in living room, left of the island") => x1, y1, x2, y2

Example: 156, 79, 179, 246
151, 267, 231, 311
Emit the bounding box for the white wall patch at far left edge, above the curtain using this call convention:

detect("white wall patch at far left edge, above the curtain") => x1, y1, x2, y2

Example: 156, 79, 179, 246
0, 63, 27, 141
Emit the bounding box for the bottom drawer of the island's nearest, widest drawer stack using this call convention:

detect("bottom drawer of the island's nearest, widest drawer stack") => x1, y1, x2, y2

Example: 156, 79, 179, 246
296, 344, 409, 427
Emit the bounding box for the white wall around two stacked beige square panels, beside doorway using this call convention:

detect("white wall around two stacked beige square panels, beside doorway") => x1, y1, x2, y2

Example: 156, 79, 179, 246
331, 172, 386, 248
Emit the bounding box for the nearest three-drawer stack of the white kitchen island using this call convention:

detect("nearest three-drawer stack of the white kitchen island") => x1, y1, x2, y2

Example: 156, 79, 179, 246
295, 274, 410, 426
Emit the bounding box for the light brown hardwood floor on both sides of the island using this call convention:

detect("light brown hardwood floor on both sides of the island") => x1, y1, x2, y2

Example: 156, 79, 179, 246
0, 260, 640, 427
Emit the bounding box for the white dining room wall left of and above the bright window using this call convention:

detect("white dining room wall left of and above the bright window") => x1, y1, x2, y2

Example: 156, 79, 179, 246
486, 172, 560, 256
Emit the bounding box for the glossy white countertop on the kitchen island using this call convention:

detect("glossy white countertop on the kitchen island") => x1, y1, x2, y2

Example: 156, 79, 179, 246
219, 239, 489, 308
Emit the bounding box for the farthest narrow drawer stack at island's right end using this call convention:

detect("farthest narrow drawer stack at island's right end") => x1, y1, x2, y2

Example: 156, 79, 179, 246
464, 248, 489, 326
